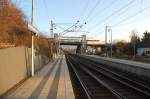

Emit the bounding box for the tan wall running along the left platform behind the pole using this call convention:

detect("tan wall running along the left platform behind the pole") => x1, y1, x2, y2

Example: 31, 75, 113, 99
0, 47, 49, 95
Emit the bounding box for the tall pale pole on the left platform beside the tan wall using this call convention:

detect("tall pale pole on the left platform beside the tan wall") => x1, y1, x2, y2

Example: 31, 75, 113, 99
31, 0, 34, 77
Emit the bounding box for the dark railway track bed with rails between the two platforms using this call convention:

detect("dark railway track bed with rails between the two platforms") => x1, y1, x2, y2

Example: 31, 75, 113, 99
66, 54, 150, 99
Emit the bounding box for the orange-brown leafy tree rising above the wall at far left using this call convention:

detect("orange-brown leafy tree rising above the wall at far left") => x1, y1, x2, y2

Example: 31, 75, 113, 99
0, 0, 31, 45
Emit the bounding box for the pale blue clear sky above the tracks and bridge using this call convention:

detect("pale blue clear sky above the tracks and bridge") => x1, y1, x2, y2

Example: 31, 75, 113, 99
12, 0, 150, 40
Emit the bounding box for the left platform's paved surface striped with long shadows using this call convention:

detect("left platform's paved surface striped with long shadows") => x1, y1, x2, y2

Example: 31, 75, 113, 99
5, 56, 75, 99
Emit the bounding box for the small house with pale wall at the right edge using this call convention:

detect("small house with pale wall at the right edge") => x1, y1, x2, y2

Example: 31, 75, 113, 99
137, 39, 150, 56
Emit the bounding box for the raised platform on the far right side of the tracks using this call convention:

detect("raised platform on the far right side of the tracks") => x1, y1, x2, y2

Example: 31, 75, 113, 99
83, 55, 150, 79
